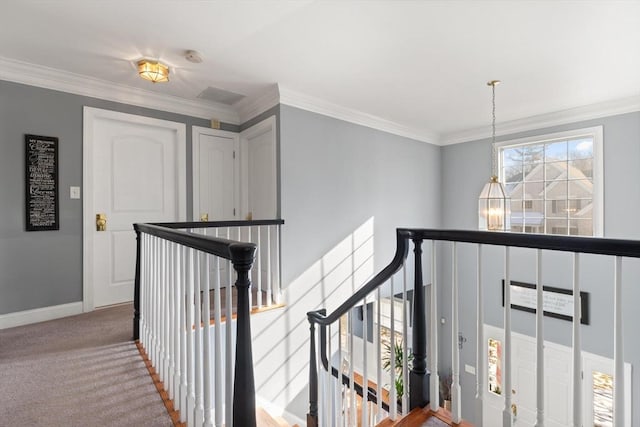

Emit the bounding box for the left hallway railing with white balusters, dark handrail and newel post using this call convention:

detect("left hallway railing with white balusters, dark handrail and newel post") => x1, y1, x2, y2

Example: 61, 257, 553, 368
133, 220, 283, 427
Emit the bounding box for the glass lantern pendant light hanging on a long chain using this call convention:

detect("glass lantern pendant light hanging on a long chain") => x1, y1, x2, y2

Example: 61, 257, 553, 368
478, 80, 511, 231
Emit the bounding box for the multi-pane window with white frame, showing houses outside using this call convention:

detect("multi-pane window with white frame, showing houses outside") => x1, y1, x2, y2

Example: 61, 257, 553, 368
498, 127, 603, 236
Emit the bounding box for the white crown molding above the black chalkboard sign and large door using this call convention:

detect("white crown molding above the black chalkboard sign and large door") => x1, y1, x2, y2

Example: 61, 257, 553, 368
0, 57, 240, 124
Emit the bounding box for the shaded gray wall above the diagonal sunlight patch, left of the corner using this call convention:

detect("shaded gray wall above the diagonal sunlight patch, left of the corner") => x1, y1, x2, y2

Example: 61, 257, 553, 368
280, 105, 440, 286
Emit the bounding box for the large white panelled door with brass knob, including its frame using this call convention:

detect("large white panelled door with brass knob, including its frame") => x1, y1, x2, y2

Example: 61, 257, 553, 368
83, 107, 186, 311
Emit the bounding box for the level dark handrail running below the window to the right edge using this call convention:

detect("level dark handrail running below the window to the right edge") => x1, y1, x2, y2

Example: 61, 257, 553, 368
401, 228, 640, 258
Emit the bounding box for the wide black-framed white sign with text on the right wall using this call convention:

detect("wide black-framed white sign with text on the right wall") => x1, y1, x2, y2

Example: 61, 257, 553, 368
502, 280, 589, 325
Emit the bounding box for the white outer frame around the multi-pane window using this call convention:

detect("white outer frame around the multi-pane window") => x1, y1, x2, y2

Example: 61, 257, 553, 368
495, 126, 604, 237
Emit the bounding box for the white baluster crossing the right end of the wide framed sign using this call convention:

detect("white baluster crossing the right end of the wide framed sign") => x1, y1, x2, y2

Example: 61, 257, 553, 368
571, 253, 582, 427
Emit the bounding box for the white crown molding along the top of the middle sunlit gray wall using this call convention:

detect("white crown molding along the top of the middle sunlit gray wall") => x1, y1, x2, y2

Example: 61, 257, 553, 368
279, 86, 439, 144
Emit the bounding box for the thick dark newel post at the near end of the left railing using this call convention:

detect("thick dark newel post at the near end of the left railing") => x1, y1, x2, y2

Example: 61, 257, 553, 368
229, 243, 256, 427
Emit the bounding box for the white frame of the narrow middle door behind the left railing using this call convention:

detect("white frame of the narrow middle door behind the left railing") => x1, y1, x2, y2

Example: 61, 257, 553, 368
191, 126, 240, 221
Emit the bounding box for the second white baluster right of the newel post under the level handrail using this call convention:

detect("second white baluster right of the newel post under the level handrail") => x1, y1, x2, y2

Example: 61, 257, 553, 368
451, 242, 462, 423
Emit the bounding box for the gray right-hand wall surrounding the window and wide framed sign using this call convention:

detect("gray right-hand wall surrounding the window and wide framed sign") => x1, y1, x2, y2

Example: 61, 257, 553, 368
439, 112, 640, 425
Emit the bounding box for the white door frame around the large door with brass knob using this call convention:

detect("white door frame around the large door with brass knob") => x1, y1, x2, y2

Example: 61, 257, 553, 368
82, 106, 187, 312
